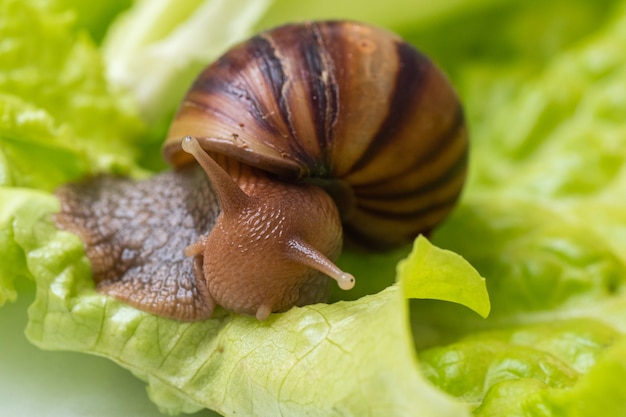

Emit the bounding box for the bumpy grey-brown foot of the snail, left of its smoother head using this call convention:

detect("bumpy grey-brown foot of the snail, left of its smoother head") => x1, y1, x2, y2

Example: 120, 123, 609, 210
55, 166, 220, 320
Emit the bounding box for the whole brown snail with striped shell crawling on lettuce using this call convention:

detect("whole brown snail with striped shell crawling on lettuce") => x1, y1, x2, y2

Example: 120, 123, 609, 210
56, 21, 468, 320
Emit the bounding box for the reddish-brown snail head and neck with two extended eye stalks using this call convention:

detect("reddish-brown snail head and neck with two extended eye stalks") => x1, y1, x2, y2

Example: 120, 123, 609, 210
178, 137, 354, 320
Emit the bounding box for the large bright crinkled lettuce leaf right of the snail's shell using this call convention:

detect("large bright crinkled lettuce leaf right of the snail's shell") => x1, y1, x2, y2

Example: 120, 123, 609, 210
436, 0, 626, 315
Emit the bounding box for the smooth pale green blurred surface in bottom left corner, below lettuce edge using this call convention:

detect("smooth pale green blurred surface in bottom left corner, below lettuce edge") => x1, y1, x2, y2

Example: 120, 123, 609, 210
0, 280, 207, 417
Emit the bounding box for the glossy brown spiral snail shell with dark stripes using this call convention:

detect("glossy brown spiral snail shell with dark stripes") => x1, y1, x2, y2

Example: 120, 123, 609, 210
164, 21, 468, 246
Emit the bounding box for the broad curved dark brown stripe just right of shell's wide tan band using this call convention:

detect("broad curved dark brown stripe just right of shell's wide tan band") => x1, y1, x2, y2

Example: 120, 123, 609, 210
346, 42, 432, 175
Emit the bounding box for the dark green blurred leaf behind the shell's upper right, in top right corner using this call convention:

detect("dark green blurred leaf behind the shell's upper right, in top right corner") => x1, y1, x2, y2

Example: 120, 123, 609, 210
404, 0, 623, 145
